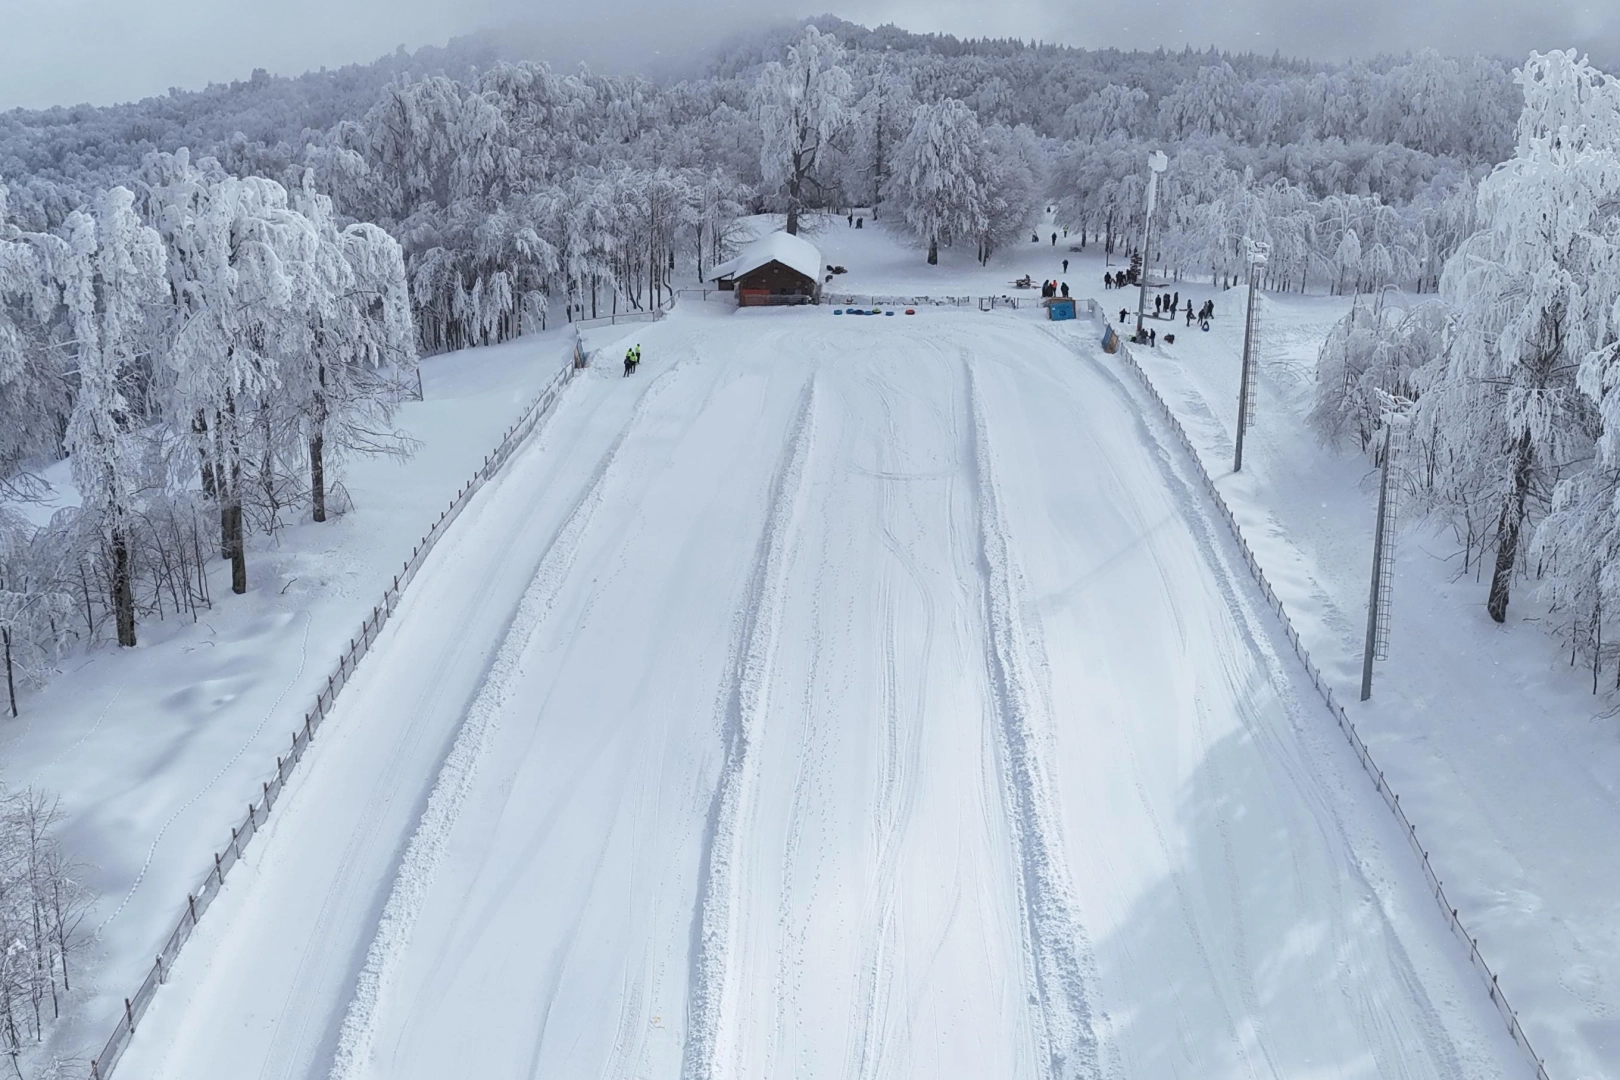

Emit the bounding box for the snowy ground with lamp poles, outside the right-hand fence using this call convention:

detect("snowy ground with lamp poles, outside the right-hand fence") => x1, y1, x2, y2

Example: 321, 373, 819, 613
1105, 290, 1620, 1078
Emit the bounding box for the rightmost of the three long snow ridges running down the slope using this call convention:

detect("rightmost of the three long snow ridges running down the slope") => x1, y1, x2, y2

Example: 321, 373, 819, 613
964, 365, 1100, 1080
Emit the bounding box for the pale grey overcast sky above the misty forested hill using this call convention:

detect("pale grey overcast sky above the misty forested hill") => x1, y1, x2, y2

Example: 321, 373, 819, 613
0, 0, 1620, 108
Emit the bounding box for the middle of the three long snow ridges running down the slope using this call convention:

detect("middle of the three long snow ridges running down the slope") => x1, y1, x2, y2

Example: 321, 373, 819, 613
680, 376, 816, 1080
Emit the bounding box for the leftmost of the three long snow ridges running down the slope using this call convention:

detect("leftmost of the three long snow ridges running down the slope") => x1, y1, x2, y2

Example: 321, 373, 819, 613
329, 366, 699, 1080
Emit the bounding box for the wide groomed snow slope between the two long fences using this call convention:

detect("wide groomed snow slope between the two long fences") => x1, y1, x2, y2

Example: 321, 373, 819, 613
120, 304, 1528, 1080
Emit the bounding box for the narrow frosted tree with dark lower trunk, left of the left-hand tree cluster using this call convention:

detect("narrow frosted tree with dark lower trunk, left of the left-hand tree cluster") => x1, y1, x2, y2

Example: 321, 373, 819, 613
63, 188, 165, 646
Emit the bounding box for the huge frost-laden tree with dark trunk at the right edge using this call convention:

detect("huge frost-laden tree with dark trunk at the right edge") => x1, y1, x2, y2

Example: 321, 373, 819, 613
1419, 52, 1620, 622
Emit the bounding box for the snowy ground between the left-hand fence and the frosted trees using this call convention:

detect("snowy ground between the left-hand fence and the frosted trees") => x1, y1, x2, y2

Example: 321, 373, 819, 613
0, 330, 586, 1057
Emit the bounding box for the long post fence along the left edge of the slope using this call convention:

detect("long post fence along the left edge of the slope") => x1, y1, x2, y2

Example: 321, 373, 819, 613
89, 348, 585, 1080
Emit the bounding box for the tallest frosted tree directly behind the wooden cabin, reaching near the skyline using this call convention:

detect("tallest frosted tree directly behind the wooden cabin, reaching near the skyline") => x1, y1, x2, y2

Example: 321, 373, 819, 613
758, 26, 854, 233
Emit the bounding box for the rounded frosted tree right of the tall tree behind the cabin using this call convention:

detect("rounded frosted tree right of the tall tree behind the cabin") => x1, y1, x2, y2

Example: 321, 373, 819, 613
889, 99, 990, 266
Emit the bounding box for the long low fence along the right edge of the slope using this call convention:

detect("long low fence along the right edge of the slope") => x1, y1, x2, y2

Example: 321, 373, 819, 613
1081, 300, 1552, 1080
